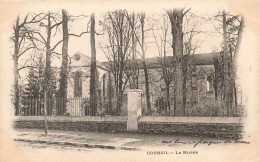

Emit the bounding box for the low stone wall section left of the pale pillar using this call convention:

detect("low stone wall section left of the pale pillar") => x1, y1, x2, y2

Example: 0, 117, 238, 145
13, 116, 127, 132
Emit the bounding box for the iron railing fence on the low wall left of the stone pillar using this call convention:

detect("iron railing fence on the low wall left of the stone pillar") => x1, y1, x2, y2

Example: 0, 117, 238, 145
19, 97, 127, 117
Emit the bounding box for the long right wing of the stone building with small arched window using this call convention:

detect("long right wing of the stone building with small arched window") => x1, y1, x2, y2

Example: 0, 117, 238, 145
125, 53, 220, 114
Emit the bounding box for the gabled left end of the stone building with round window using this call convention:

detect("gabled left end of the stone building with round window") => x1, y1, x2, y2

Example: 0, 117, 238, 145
67, 52, 109, 116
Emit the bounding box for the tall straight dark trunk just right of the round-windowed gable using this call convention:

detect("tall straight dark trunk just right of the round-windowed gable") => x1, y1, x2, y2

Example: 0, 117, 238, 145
90, 13, 97, 116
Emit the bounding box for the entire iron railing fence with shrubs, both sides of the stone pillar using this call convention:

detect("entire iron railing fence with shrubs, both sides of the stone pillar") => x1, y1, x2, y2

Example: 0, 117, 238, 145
19, 92, 246, 117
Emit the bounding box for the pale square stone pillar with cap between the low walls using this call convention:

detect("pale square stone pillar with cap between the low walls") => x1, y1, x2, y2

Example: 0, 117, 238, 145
127, 89, 142, 132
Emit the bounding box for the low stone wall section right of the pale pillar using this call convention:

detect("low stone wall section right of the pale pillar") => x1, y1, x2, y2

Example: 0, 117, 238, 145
138, 117, 243, 139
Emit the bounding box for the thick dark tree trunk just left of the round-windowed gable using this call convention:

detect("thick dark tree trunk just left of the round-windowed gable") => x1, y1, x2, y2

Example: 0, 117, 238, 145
57, 9, 69, 115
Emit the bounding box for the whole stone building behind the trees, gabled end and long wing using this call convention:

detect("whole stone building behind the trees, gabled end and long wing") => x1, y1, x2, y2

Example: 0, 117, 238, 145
68, 52, 228, 116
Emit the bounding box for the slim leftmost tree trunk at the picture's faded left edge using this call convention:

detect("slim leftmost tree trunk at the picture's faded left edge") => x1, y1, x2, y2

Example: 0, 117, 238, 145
13, 16, 20, 115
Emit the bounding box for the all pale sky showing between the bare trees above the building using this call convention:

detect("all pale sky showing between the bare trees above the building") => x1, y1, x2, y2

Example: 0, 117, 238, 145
15, 8, 225, 79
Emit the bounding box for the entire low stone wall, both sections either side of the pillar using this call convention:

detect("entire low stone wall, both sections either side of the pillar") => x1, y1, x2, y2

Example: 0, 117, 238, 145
13, 116, 243, 139
